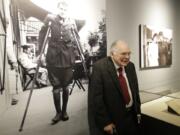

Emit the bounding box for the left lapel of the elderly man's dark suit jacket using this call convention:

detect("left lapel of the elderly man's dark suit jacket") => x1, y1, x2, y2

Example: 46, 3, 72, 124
107, 57, 120, 91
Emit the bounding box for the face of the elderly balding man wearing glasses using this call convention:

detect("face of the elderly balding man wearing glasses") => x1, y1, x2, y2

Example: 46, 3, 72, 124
111, 42, 131, 67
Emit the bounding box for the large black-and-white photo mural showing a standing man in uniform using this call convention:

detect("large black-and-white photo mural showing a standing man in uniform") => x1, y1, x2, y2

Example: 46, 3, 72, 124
0, 0, 107, 135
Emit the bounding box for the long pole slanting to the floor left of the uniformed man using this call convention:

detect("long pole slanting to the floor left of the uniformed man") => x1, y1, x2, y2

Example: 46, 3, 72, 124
19, 22, 51, 132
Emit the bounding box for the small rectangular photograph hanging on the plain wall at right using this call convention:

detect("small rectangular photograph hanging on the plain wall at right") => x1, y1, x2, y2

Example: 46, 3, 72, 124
140, 25, 172, 68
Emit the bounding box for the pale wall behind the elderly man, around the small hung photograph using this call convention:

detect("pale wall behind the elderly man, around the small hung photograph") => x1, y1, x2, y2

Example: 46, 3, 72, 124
106, 0, 180, 91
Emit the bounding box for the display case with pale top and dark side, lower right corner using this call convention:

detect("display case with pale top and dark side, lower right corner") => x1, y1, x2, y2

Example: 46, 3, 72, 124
140, 91, 180, 135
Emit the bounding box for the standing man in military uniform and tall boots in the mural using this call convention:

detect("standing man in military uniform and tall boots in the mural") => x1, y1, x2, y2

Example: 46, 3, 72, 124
39, 0, 78, 124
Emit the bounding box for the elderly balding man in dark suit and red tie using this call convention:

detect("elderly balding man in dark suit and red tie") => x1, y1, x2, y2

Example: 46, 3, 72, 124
88, 40, 141, 135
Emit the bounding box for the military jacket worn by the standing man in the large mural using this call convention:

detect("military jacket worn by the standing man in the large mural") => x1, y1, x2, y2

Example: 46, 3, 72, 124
39, 15, 75, 68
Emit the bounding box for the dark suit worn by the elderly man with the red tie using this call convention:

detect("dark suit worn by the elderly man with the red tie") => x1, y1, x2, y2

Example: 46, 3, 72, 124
88, 57, 140, 135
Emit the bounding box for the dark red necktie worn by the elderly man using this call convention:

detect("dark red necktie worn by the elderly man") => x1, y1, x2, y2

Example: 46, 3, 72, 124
118, 68, 130, 105
